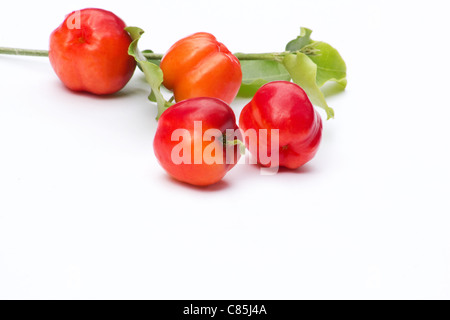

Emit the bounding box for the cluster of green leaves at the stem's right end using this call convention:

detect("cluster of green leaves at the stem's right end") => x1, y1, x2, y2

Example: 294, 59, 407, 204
239, 28, 347, 119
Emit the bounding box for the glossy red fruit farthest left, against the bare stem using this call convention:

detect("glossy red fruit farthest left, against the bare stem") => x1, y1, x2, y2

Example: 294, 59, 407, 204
49, 9, 136, 95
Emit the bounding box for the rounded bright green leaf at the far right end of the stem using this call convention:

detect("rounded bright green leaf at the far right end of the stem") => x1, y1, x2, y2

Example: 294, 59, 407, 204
309, 42, 347, 89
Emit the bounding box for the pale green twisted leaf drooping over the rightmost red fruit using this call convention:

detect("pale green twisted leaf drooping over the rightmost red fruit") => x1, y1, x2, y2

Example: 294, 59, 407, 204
283, 53, 334, 119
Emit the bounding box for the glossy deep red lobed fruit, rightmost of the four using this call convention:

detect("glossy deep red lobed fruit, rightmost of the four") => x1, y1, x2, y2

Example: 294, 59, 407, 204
239, 81, 322, 169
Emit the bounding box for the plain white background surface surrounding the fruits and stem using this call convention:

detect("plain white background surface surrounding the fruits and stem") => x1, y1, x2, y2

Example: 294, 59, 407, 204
0, 0, 450, 299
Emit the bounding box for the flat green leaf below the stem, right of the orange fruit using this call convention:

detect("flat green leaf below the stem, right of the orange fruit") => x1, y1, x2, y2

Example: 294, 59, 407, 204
238, 60, 291, 98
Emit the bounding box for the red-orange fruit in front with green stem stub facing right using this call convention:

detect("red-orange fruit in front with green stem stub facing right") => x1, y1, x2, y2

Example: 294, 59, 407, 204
153, 98, 241, 186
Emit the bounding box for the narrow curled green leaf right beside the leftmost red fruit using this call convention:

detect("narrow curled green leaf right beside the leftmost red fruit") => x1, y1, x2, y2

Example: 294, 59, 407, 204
125, 27, 172, 119
